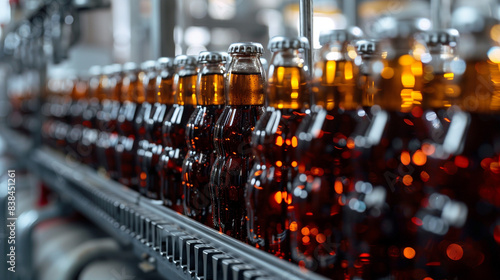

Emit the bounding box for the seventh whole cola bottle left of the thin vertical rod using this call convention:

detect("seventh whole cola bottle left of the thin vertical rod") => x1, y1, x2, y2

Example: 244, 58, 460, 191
116, 62, 145, 189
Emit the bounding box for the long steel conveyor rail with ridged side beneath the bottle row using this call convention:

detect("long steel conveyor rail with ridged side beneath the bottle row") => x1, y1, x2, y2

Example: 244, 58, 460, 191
0, 126, 326, 280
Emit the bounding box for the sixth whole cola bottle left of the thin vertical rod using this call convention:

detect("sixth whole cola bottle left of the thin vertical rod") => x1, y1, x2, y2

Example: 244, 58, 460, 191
135, 60, 160, 199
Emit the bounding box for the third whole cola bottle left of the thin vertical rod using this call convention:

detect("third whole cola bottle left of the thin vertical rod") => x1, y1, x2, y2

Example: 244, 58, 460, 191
182, 52, 227, 227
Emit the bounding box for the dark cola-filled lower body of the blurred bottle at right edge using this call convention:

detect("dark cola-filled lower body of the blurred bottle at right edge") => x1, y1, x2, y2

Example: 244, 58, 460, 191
415, 112, 500, 279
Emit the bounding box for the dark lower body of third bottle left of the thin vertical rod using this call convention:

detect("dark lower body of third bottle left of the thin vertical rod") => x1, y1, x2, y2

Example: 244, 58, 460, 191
182, 104, 224, 227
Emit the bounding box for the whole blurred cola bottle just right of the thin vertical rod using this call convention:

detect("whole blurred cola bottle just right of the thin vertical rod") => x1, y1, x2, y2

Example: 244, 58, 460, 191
290, 27, 367, 278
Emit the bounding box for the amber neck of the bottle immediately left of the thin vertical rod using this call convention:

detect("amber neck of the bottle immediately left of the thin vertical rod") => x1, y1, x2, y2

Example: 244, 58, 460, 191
266, 49, 310, 110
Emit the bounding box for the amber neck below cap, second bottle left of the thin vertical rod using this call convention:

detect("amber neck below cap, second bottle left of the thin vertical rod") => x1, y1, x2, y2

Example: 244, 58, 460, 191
226, 54, 265, 106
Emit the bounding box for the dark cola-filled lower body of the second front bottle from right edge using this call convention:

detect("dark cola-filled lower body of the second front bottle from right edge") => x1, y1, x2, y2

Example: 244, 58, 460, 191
343, 107, 432, 279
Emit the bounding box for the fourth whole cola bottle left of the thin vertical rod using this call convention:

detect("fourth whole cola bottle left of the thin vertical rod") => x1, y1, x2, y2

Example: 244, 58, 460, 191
159, 55, 198, 213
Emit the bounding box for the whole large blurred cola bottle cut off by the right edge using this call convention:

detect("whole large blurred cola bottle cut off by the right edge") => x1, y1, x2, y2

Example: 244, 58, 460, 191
415, 14, 500, 279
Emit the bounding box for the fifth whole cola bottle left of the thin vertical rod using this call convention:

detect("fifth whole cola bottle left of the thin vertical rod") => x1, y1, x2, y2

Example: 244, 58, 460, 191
143, 57, 175, 199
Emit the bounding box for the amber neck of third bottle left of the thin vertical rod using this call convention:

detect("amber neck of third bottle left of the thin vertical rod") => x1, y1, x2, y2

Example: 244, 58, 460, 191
196, 63, 225, 106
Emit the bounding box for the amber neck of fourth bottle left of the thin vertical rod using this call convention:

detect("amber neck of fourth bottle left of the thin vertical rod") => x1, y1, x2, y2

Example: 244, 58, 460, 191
174, 67, 197, 106
